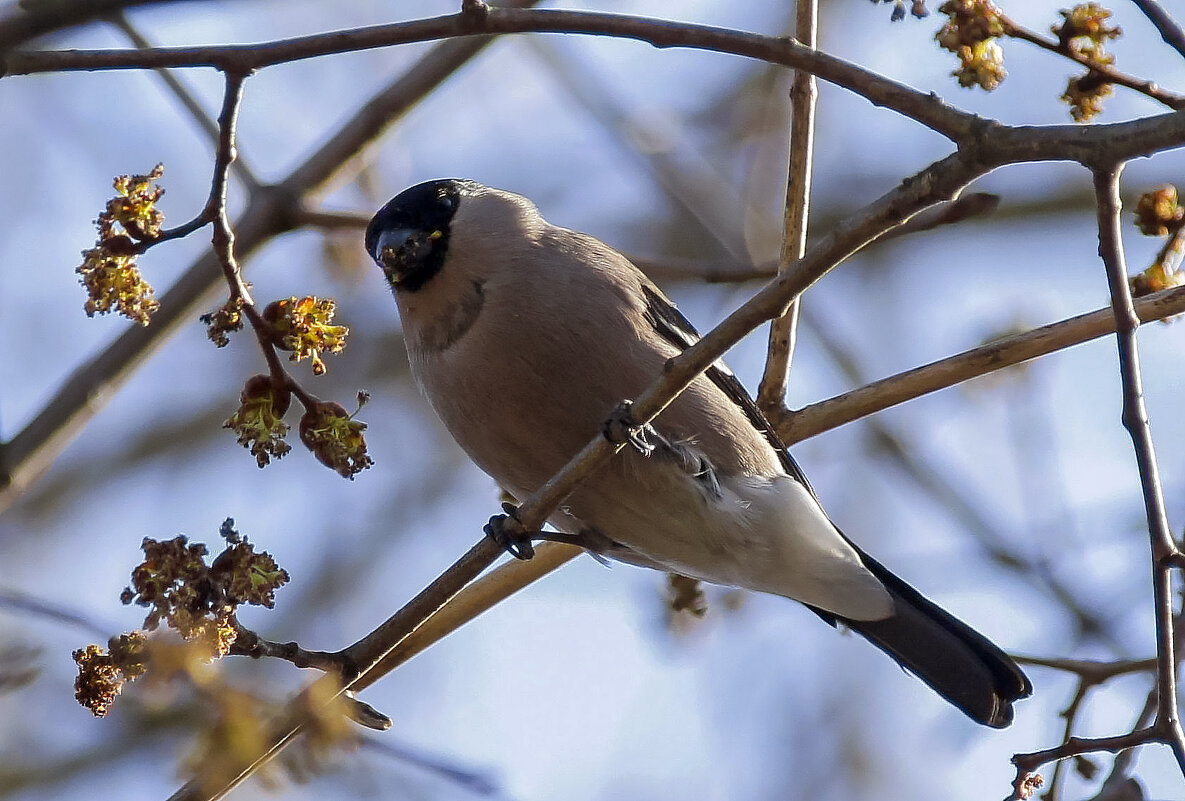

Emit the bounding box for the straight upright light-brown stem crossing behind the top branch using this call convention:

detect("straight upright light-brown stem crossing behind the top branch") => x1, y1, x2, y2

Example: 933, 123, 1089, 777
757, 0, 819, 412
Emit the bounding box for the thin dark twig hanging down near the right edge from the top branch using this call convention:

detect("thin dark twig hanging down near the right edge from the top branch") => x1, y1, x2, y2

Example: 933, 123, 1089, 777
1095, 164, 1185, 775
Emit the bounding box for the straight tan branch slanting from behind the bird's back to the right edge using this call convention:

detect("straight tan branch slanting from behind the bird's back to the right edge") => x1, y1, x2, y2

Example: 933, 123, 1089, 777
770, 287, 1185, 444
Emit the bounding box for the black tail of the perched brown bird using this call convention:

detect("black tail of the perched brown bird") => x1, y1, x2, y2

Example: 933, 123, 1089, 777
815, 552, 1032, 729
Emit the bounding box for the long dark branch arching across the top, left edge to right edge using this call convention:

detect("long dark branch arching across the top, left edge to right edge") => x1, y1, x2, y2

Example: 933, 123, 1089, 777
4, 8, 1185, 157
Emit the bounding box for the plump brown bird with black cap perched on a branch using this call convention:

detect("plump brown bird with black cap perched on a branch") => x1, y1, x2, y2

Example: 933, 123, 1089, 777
365, 179, 1032, 729
